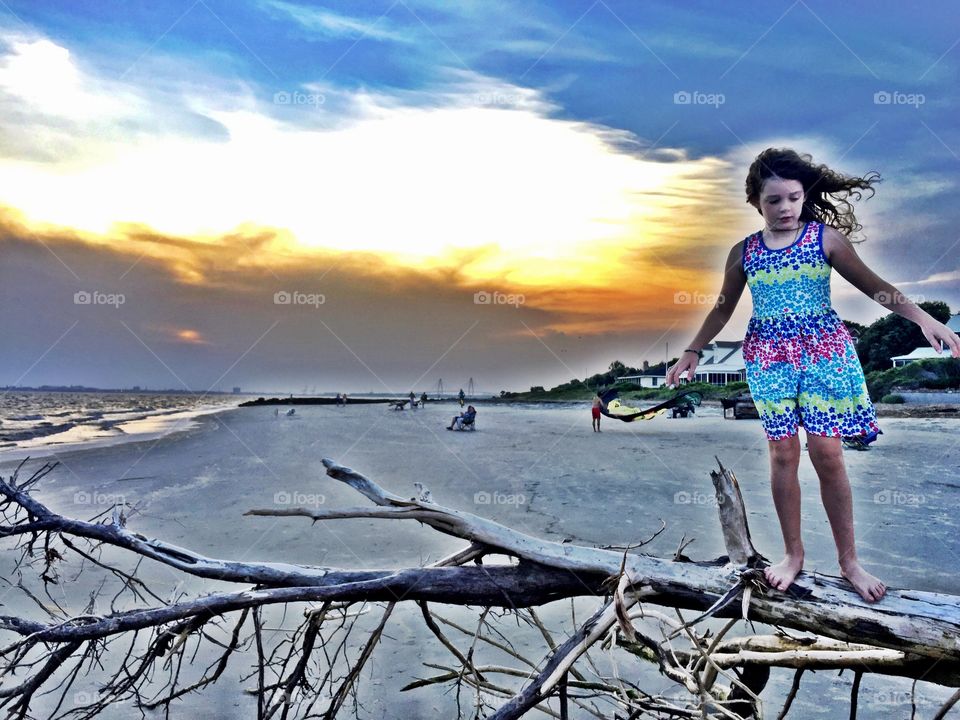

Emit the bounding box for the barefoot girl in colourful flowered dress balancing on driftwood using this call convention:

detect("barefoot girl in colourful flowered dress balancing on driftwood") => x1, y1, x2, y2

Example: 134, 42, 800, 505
666, 148, 960, 602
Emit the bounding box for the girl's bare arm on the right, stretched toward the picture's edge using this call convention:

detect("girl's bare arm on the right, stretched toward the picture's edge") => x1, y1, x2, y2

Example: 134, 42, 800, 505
823, 225, 960, 358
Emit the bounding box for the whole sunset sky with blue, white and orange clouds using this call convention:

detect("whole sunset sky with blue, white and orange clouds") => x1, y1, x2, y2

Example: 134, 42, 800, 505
0, 0, 960, 393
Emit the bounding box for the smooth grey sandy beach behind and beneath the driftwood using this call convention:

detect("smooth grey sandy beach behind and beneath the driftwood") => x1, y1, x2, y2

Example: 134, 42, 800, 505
0, 404, 960, 718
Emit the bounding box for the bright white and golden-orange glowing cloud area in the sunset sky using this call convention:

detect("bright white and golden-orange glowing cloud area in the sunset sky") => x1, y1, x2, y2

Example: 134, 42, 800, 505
0, 33, 745, 334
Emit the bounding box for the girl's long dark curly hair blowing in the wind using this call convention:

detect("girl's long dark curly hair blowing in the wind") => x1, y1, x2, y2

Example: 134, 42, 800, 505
746, 148, 881, 237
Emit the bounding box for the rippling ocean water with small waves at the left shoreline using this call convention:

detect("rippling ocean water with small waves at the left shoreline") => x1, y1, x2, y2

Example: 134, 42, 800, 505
0, 390, 240, 459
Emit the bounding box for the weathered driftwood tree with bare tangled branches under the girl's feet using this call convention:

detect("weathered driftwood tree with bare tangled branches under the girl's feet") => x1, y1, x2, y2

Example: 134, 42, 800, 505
0, 459, 960, 719
